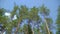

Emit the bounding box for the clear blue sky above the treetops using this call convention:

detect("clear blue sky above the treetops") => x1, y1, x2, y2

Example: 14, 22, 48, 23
0, 0, 60, 33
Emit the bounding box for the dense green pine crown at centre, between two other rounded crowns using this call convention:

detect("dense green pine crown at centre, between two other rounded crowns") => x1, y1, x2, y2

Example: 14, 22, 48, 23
29, 7, 40, 21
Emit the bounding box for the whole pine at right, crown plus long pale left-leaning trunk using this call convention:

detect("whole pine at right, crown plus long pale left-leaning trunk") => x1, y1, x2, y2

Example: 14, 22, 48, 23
39, 4, 50, 34
